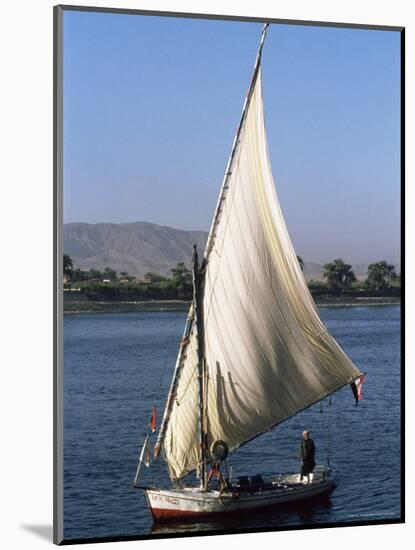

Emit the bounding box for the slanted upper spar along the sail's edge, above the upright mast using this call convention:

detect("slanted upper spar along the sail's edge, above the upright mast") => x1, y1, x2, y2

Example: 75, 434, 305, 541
205, 23, 269, 260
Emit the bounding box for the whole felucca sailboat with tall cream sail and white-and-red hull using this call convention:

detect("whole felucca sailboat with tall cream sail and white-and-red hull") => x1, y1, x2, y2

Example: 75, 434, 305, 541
134, 24, 363, 520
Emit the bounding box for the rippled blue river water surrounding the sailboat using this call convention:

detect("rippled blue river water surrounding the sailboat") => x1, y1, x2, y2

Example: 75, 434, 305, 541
64, 306, 400, 539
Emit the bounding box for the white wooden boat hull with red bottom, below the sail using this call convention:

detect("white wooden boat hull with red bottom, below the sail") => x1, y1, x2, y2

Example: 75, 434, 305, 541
145, 476, 334, 520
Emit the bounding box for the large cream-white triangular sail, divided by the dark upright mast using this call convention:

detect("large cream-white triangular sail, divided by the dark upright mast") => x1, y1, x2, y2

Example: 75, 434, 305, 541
163, 69, 361, 479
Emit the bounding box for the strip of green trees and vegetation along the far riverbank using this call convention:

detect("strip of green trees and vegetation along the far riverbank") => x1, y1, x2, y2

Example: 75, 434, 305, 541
63, 254, 400, 302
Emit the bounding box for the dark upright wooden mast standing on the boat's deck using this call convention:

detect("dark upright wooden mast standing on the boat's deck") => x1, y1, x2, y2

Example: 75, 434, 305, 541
192, 245, 210, 488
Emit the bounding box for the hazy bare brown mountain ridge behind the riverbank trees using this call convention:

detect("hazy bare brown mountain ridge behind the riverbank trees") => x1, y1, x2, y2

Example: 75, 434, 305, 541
63, 222, 400, 281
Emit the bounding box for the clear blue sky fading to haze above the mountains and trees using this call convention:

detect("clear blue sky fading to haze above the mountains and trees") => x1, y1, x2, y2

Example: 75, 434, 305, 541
64, 12, 400, 263
